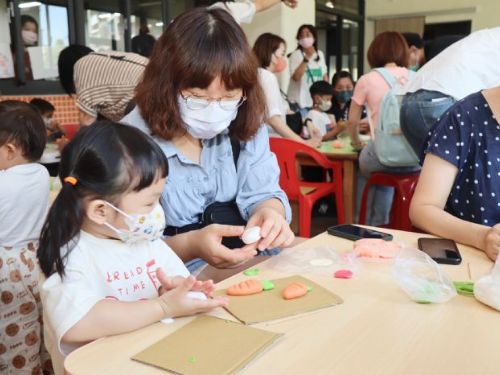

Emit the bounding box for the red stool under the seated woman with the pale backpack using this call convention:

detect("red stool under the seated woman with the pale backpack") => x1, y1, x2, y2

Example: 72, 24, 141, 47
359, 172, 420, 231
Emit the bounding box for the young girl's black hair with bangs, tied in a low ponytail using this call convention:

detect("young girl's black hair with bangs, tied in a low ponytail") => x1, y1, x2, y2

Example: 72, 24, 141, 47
37, 121, 168, 277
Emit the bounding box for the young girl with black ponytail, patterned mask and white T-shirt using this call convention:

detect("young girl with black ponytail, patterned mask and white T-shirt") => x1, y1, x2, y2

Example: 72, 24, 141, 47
38, 122, 226, 373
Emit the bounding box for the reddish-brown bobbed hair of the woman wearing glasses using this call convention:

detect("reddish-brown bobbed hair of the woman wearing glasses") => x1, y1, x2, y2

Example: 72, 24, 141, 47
135, 8, 265, 141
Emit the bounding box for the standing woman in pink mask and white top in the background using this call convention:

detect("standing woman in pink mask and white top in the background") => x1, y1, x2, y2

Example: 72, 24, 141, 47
288, 25, 328, 108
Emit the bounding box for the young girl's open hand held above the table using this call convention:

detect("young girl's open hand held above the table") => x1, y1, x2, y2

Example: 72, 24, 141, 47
156, 276, 228, 318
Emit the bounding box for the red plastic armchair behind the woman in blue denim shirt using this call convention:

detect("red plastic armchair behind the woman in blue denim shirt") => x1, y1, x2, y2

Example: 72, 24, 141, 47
269, 137, 345, 237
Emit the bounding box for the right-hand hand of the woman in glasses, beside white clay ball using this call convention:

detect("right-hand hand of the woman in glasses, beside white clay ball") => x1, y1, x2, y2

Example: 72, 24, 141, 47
247, 207, 295, 251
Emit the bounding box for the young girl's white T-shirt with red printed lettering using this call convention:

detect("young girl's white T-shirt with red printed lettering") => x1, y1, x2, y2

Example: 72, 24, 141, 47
40, 231, 189, 374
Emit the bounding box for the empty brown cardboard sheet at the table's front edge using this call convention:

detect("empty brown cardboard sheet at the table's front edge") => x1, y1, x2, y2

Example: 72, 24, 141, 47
132, 316, 281, 375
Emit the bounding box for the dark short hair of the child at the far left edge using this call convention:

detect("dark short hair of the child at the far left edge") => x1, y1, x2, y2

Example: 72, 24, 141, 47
0, 100, 47, 162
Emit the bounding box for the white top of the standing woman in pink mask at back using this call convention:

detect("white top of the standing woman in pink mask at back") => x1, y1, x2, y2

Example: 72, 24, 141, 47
288, 49, 328, 108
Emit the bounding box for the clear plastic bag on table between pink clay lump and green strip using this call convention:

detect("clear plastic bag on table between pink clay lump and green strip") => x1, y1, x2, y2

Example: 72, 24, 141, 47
392, 248, 457, 303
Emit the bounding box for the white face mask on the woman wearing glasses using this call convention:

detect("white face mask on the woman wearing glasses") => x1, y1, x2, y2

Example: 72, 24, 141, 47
177, 95, 241, 139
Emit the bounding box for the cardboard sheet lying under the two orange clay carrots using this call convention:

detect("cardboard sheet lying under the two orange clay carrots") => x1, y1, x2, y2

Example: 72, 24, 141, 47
216, 275, 344, 324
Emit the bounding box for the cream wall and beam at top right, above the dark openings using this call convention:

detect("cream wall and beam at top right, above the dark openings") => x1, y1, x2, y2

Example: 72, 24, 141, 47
365, 0, 500, 72
